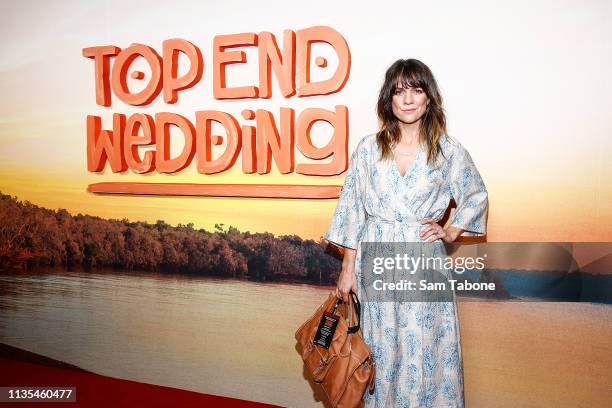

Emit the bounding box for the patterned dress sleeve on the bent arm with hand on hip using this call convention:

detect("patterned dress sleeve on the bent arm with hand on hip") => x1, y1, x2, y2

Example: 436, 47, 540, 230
450, 145, 489, 236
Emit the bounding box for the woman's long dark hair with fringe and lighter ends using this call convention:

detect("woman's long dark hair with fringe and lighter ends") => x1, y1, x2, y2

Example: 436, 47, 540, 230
376, 59, 446, 163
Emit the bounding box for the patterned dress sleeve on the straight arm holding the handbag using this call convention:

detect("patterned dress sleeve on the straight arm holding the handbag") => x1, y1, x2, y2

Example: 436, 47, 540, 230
323, 143, 366, 249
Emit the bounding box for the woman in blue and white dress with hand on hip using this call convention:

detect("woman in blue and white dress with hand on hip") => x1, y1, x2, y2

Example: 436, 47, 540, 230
324, 59, 488, 408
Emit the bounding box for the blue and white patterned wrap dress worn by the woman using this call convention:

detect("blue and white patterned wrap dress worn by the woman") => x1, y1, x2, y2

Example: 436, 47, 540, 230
324, 134, 488, 408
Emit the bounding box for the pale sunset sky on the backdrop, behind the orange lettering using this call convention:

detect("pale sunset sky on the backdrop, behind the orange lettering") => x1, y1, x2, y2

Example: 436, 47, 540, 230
0, 1, 612, 241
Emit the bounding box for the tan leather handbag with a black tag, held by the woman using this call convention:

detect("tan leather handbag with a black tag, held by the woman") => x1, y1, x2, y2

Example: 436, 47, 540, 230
295, 292, 376, 408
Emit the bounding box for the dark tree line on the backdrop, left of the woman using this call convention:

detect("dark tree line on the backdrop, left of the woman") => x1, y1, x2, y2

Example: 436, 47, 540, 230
0, 192, 340, 284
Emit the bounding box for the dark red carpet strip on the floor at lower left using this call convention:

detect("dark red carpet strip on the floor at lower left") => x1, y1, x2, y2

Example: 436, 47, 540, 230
0, 343, 276, 408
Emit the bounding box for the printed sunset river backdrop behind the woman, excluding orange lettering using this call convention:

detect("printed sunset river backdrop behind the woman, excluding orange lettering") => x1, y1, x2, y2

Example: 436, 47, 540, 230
0, 0, 612, 407
